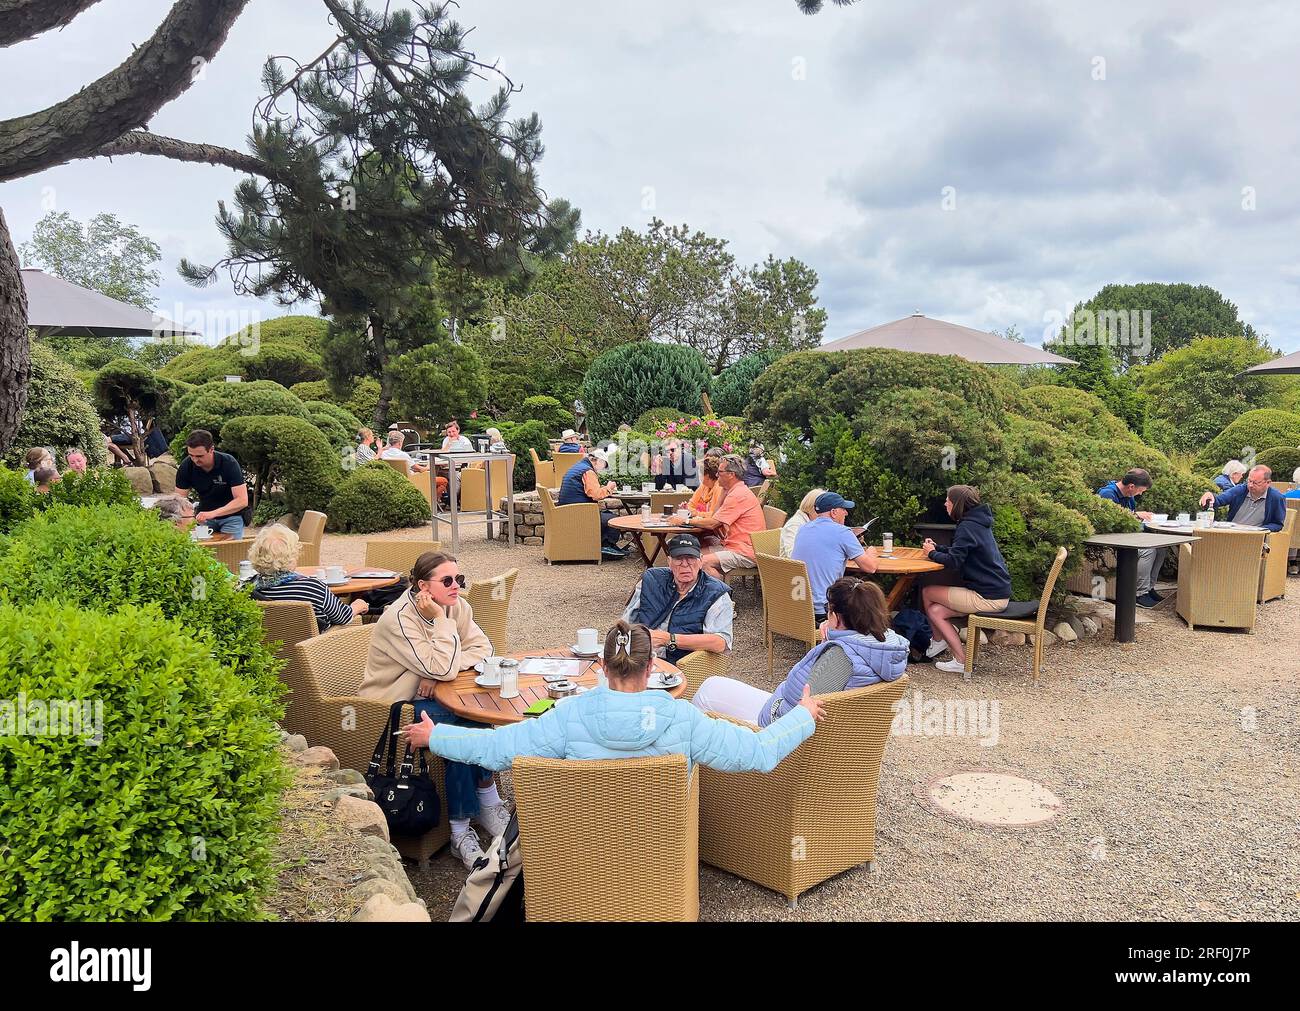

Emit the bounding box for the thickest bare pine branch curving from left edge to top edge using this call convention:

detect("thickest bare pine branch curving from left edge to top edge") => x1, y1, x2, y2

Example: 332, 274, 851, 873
0, 0, 248, 182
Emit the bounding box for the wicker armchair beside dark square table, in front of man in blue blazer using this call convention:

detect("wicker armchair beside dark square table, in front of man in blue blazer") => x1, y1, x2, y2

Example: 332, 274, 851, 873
1175, 529, 1264, 632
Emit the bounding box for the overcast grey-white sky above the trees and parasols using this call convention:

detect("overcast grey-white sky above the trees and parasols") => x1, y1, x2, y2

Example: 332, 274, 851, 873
0, 0, 1300, 351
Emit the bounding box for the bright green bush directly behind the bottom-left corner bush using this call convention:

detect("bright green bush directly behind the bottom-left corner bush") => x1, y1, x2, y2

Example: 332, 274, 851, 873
0, 506, 283, 706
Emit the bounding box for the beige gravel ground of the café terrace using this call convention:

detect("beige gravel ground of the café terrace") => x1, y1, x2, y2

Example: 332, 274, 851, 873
314, 528, 1300, 920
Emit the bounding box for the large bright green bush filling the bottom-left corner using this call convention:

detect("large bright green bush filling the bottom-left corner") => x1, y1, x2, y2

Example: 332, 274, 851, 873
0, 597, 286, 921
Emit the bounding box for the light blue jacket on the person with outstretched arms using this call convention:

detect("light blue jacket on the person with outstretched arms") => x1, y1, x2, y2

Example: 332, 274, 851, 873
429, 687, 816, 772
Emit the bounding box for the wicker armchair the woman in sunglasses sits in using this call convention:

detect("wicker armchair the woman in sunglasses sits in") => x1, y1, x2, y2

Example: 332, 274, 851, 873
293, 625, 451, 863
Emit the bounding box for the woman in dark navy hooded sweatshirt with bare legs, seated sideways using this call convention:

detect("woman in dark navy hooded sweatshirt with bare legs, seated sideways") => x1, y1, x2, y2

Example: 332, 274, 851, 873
920, 485, 1011, 674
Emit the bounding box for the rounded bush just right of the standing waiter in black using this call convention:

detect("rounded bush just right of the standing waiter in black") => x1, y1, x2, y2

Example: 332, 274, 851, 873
221, 415, 343, 513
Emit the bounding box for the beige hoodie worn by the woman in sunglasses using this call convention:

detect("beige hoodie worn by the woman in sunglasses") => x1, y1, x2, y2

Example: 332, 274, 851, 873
356, 591, 491, 702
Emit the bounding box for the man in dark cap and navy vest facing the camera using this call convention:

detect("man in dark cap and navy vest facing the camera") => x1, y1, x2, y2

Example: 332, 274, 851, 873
623, 534, 736, 664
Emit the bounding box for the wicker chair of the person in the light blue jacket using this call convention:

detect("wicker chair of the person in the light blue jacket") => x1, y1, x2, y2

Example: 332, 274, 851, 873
514, 748, 702, 923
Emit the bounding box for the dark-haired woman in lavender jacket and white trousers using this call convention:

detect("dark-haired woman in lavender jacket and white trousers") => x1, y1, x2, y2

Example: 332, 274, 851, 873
692, 576, 907, 726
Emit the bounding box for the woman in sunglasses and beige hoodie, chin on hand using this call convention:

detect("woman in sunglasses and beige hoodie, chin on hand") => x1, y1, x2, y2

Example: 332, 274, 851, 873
356, 551, 496, 867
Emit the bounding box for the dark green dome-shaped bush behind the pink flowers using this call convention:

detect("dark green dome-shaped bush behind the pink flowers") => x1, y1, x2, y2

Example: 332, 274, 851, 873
582, 340, 712, 438
